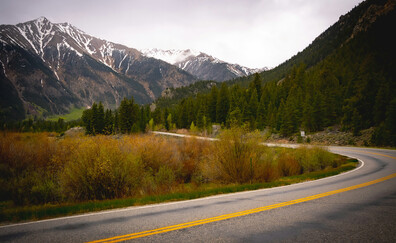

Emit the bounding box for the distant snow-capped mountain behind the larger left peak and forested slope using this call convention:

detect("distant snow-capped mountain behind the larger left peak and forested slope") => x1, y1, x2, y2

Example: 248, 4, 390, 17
141, 48, 267, 82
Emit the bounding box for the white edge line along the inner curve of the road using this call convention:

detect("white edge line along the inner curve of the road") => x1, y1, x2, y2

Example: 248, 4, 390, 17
0, 143, 364, 229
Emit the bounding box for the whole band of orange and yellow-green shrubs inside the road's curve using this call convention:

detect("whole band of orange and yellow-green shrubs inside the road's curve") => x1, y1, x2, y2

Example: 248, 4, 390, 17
0, 128, 339, 205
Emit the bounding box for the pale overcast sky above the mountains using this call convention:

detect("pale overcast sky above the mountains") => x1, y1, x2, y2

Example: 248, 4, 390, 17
0, 0, 362, 68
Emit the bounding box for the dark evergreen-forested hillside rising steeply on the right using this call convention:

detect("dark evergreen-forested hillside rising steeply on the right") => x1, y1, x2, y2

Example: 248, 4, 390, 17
148, 1, 396, 144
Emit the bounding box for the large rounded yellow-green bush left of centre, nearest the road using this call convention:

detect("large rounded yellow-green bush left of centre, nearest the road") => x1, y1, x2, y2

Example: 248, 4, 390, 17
60, 136, 142, 200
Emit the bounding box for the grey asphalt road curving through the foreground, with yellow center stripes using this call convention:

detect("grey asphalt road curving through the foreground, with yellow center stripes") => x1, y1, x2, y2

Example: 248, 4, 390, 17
0, 147, 396, 242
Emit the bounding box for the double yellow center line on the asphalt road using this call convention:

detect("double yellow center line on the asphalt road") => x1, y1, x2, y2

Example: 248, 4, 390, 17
87, 171, 396, 243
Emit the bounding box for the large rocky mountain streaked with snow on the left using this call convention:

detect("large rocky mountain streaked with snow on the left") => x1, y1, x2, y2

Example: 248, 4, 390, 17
0, 17, 196, 119
